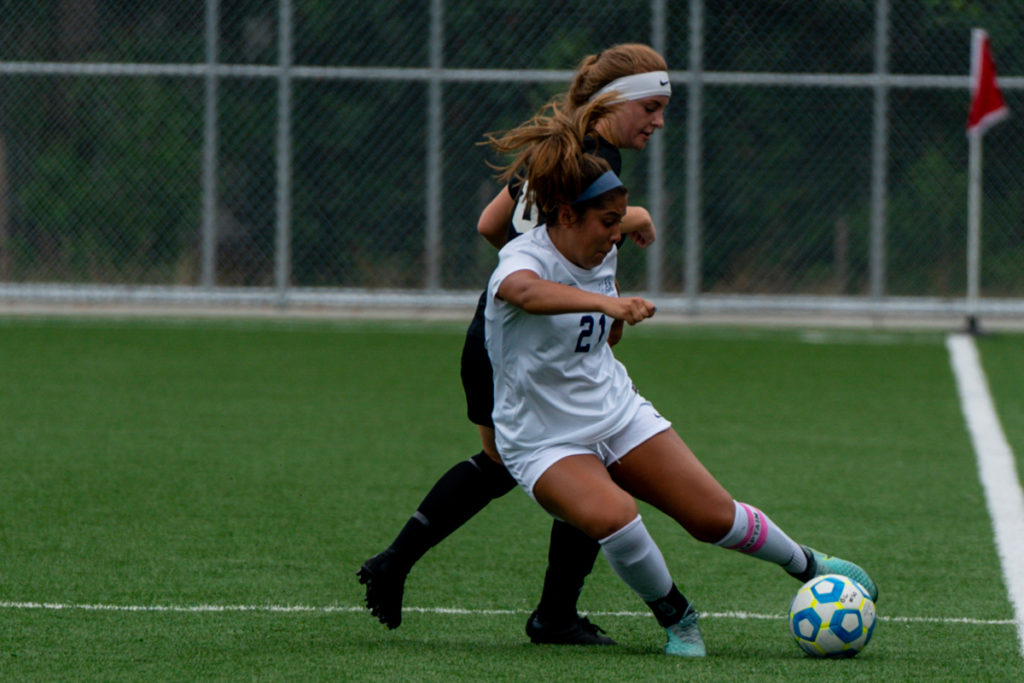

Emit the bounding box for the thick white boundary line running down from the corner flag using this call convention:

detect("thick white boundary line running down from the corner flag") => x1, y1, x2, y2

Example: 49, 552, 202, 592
946, 335, 1024, 656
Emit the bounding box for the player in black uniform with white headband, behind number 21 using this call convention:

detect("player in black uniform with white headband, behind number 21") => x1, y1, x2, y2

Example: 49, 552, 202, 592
358, 43, 672, 645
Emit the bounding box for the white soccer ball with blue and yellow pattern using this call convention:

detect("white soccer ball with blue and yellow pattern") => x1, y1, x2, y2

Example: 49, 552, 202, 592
790, 573, 876, 657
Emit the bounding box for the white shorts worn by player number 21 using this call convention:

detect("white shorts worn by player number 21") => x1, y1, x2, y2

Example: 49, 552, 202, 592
502, 399, 672, 500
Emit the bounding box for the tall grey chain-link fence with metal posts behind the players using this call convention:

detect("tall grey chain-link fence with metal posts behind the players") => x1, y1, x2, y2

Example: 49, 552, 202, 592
0, 0, 1024, 315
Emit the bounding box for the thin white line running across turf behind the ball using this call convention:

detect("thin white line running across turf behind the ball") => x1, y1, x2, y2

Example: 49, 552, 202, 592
0, 601, 1015, 626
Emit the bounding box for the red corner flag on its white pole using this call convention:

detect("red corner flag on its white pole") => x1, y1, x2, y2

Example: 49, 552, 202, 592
967, 29, 1010, 334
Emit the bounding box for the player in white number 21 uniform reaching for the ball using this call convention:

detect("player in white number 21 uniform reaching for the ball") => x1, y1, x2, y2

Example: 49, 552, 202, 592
485, 98, 878, 657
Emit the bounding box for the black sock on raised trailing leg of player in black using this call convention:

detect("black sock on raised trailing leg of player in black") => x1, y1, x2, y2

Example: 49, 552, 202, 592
390, 451, 515, 567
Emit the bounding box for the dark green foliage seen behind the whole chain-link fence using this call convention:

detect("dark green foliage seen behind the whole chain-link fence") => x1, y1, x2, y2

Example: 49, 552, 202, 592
0, 0, 1024, 296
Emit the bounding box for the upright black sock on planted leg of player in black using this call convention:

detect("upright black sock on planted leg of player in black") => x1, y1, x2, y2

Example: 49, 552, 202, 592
537, 519, 601, 624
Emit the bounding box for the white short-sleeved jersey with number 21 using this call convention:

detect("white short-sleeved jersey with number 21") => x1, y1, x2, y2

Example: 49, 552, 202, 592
484, 225, 637, 456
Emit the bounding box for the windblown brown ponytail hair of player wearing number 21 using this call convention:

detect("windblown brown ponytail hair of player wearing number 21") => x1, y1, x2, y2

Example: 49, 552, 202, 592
483, 93, 625, 218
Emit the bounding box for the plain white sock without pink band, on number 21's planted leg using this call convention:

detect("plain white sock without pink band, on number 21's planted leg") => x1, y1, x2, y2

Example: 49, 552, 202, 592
599, 515, 672, 602
